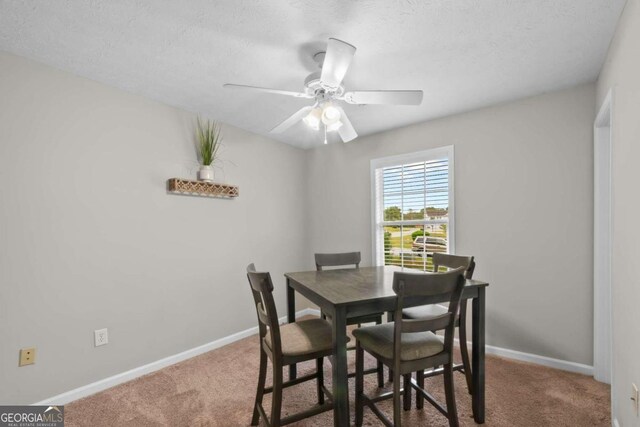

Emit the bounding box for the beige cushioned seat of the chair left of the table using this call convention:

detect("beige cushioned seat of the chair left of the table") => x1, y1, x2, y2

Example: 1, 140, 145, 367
264, 319, 333, 356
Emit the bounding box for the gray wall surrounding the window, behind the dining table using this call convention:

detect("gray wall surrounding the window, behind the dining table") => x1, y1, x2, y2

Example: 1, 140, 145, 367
308, 85, 595, 364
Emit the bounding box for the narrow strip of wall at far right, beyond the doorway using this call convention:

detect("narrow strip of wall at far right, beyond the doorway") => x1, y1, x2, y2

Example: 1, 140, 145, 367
598, 0, 640, 427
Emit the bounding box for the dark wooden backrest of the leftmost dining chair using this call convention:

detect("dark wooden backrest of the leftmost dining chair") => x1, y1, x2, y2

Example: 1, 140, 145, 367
247, 263, 282, 354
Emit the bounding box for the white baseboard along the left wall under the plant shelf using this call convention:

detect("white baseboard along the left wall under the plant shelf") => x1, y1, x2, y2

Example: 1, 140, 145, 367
34, 308, 320, 405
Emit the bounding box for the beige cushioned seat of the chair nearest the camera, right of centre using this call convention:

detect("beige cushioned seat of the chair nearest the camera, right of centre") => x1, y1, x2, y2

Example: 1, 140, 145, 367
353, 322, 444, 362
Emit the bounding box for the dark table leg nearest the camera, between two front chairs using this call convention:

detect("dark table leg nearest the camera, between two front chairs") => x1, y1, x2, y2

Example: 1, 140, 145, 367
332, 307, 351, 427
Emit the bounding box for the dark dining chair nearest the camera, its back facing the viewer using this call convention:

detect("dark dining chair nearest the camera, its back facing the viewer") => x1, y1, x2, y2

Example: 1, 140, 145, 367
353, 267, 465, 427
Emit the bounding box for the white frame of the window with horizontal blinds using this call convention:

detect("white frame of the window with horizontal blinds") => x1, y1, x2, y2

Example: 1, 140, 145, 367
370, 145, 456, 266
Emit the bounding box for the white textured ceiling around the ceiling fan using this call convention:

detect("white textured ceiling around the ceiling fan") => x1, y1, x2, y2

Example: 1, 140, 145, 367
0, 0, 625, 147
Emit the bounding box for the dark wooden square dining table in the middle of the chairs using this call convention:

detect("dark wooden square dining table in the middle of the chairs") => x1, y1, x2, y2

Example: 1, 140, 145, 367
285, 266, 489, 427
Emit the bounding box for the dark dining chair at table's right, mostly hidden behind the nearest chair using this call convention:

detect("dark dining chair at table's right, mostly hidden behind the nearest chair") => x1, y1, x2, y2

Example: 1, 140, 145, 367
402, 253, 476, 394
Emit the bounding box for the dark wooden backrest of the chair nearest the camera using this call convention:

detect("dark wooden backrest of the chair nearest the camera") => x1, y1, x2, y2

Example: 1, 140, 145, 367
393, 267, 466, 360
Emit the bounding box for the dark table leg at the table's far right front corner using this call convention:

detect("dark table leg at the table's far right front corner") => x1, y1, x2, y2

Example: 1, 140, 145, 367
471, 288, 485, 424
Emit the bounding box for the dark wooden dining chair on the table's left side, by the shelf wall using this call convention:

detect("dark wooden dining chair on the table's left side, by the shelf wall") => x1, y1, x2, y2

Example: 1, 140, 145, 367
247, 264, 333, 427
